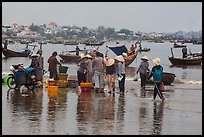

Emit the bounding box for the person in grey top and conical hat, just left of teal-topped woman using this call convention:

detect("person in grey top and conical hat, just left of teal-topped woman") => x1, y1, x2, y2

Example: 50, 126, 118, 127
137, 55, 150, 88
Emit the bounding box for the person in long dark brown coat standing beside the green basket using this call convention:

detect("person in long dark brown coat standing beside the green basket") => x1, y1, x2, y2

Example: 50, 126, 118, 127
47, 51, 61, 80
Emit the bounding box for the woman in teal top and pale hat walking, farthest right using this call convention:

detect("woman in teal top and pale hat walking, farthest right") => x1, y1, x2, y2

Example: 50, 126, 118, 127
148, 58, 165, 101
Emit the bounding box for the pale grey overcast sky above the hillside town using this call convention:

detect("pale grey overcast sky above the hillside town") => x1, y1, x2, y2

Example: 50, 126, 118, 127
2, 2, 202, 33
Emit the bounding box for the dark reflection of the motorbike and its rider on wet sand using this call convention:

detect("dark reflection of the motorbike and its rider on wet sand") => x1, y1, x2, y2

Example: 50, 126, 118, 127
7, 88, 43, 133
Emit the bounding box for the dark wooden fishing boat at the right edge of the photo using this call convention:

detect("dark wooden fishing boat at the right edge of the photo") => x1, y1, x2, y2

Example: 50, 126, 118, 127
169, 48, 202, 65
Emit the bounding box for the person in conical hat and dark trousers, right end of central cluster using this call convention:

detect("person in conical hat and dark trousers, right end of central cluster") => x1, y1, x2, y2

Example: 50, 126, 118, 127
115, 55, 126, 92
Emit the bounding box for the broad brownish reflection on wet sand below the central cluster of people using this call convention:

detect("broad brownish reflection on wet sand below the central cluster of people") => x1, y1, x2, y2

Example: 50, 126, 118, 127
77, 92, 115, 135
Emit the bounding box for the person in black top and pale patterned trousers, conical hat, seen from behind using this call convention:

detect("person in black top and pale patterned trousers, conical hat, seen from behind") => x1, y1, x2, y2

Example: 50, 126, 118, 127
105, 58, 116, 93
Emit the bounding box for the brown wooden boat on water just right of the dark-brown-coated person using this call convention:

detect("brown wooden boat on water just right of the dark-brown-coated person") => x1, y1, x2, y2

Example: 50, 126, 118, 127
59, 54, 81, 63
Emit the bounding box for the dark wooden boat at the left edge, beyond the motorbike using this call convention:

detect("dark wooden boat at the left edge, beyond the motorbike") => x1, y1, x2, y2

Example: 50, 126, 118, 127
2, 48, 31, 57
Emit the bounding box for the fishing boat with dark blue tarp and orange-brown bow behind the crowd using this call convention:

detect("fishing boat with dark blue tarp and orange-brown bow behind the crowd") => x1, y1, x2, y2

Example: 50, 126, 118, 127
106, 45, 139, 67
